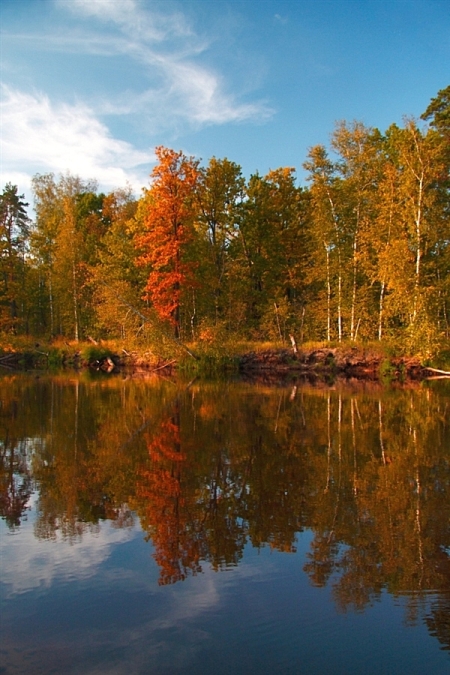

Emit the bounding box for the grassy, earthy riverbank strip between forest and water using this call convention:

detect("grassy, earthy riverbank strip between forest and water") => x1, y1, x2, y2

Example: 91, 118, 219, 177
0, 343, 450, 381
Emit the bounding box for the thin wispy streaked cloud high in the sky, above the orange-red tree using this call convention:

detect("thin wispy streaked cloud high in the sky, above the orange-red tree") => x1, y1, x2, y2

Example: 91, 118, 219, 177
57, 0, 273, 128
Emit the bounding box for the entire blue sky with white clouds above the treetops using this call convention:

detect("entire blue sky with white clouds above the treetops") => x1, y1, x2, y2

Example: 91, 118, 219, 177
0, 0, 450, 201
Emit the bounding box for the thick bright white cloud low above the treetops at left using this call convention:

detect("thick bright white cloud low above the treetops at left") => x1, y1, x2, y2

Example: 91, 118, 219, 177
1, 86, 154, 190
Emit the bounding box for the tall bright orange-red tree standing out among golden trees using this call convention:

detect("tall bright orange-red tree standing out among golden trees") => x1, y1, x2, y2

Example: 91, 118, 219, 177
135, 146, 199, 338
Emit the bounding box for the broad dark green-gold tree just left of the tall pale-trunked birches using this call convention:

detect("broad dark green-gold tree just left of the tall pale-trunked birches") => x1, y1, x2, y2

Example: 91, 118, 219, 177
230, 167, 306, 340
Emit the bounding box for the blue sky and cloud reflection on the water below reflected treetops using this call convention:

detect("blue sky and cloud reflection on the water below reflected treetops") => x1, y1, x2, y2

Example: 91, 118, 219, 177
0, 504, 449, 675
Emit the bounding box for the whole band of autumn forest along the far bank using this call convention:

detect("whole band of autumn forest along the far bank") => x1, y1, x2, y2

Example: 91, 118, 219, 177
0, 86, 450, 356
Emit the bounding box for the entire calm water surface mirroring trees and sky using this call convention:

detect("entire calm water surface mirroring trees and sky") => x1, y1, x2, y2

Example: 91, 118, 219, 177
0, 373, 450, 675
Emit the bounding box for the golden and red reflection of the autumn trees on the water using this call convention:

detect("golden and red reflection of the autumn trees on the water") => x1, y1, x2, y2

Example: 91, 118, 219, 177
2, 380, 450, 648
